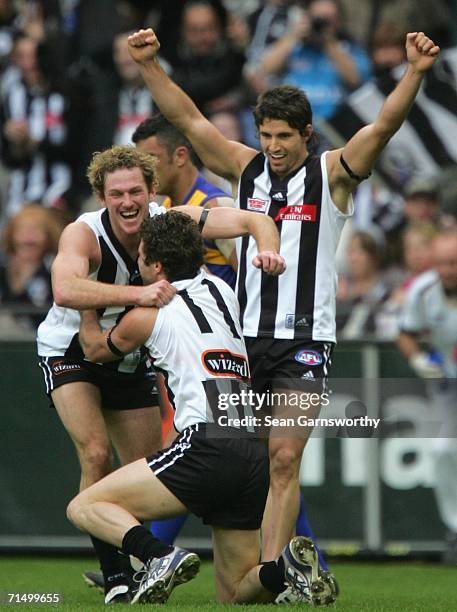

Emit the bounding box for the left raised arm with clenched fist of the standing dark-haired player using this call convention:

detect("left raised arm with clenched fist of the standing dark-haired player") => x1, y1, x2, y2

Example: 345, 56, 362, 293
128, 29, 256, 182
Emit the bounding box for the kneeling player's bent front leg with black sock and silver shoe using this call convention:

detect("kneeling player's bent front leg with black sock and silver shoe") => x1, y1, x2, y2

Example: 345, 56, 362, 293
67, 459, 200, 603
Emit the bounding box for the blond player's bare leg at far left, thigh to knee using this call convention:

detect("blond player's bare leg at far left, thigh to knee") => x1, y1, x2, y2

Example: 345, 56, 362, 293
52, 382, 112, 490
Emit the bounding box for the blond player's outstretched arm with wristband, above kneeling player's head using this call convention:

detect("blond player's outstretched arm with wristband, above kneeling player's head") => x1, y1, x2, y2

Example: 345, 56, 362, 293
174, 206, 286, 275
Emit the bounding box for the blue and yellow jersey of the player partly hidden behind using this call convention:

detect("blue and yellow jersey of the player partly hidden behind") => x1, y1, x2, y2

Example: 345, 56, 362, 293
163, 174, 236, 289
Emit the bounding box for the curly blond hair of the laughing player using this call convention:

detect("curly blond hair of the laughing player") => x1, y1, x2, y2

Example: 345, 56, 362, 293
87, 145, 157, 200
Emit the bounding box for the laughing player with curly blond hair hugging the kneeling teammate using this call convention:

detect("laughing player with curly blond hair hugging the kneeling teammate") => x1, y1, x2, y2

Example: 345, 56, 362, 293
38, 146, 283, 603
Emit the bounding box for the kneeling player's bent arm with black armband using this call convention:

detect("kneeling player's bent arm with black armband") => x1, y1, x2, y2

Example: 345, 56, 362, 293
79, 308, 157, 363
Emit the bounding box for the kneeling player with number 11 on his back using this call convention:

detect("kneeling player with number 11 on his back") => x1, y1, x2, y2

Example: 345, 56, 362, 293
67, 212, 323, 603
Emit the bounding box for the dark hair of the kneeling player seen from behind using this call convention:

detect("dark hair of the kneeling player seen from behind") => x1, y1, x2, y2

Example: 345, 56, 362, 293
140, 211, 204, 281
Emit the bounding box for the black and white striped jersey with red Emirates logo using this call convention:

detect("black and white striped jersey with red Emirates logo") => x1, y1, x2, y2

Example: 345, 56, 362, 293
236, 153, 353, 342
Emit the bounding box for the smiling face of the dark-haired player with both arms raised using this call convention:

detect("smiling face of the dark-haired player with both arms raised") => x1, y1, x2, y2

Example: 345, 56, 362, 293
259, 119, 312, 178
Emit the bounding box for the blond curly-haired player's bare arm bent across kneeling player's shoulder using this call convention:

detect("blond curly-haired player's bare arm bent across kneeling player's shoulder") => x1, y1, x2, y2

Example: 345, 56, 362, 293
52, 222, 175, 310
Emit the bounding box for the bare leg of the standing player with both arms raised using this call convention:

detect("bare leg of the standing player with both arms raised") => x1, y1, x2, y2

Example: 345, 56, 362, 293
262, 389, 320, 561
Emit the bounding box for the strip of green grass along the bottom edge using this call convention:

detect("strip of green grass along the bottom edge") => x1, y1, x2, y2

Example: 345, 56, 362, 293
0, 557, 457, 612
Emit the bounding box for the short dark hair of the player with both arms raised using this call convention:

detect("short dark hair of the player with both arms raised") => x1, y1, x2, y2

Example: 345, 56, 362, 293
253, 85, 313, 136
